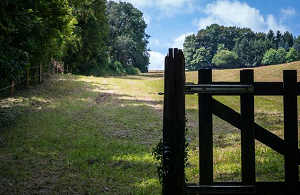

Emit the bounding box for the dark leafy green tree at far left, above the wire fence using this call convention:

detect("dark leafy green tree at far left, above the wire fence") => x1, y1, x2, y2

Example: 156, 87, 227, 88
0, 0, 74, 85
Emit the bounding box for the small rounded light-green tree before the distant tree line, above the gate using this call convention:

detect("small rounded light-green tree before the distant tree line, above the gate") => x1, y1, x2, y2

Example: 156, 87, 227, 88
212, 50, 239, 68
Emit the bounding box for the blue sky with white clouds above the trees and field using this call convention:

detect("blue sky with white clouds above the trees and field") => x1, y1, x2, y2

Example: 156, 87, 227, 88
116, 0, 300, 70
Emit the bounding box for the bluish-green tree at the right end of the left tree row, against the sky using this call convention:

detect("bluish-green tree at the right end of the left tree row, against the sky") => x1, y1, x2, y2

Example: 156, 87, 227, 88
106, 1, 150, 72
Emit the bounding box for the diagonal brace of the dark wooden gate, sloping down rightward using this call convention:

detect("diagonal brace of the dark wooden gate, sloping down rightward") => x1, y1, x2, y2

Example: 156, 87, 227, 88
212, 99, 300, 165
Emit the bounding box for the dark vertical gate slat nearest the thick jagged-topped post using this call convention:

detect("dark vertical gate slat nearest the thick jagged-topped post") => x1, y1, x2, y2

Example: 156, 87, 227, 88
198, 69, 213, 185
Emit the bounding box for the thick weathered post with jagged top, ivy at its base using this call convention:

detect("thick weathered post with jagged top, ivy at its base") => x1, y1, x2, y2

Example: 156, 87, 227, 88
162, 48, 186, 195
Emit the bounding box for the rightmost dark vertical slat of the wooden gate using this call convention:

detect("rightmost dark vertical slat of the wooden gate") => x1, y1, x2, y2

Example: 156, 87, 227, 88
283, 70, 300, 195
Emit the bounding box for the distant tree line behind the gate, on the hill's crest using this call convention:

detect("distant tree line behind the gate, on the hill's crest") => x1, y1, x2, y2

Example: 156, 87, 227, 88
183, 24, 300, 70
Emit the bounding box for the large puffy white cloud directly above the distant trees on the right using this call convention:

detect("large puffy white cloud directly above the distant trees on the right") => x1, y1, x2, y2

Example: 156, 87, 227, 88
198, 0, 287, 32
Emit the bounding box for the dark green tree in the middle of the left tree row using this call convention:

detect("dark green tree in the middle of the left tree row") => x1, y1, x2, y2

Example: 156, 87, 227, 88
65, 0, 108, 75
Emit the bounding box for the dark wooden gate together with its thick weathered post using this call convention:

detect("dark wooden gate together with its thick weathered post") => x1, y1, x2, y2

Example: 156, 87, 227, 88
163, 49, 300, 195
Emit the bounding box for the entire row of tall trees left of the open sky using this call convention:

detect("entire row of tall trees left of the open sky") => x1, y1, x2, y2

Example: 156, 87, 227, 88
0, 0, 149, 86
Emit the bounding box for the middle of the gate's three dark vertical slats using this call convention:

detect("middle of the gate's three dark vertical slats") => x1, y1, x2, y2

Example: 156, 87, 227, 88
240, 70, 255, 185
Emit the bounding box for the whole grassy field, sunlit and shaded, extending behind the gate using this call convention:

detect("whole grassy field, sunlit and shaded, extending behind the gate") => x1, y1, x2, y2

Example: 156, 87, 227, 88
0, 62, 300, 195
